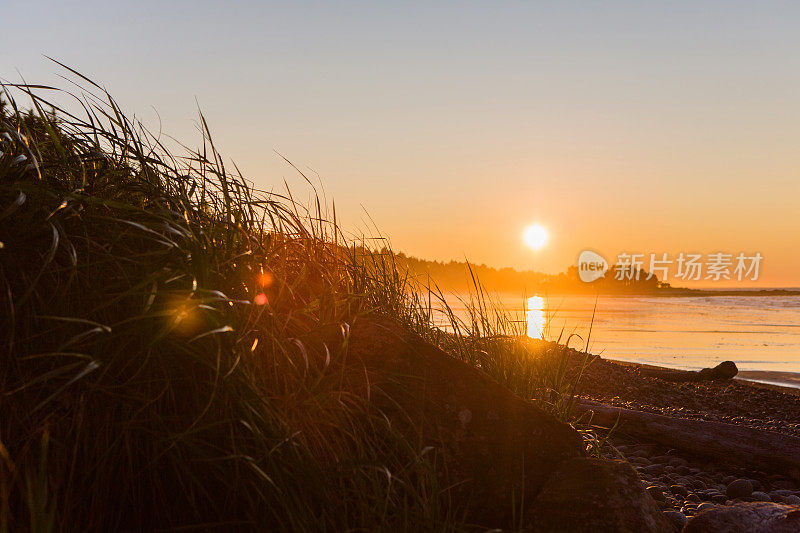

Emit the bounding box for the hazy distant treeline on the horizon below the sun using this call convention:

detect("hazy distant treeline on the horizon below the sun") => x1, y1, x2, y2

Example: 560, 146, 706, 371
396, 252, 668, 294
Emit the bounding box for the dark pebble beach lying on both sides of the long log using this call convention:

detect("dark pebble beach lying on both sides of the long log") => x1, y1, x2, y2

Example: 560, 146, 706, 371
560, 352, 800, 525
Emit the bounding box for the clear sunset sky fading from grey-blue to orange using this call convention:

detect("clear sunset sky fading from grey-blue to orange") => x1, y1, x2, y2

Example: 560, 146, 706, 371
0, 0, 800, 287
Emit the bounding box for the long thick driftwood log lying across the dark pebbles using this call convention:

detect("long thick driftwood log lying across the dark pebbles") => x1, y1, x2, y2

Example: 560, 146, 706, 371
576, 400, 800, 481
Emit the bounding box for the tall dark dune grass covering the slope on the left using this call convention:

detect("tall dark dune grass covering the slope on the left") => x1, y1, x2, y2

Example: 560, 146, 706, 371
0, 67, 592, 531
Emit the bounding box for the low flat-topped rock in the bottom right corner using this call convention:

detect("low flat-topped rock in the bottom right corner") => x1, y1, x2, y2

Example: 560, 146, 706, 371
683, 502, 800, 533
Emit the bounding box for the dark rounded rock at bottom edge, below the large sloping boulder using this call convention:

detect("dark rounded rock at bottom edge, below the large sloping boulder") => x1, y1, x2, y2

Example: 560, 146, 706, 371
529, 458, 674, 533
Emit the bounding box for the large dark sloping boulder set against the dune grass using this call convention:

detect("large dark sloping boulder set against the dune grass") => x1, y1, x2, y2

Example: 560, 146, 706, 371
346, 319, 584, 527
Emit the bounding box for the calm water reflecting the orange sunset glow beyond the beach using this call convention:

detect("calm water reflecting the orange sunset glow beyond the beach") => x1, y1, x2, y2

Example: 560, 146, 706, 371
444, 296, 800, 372
